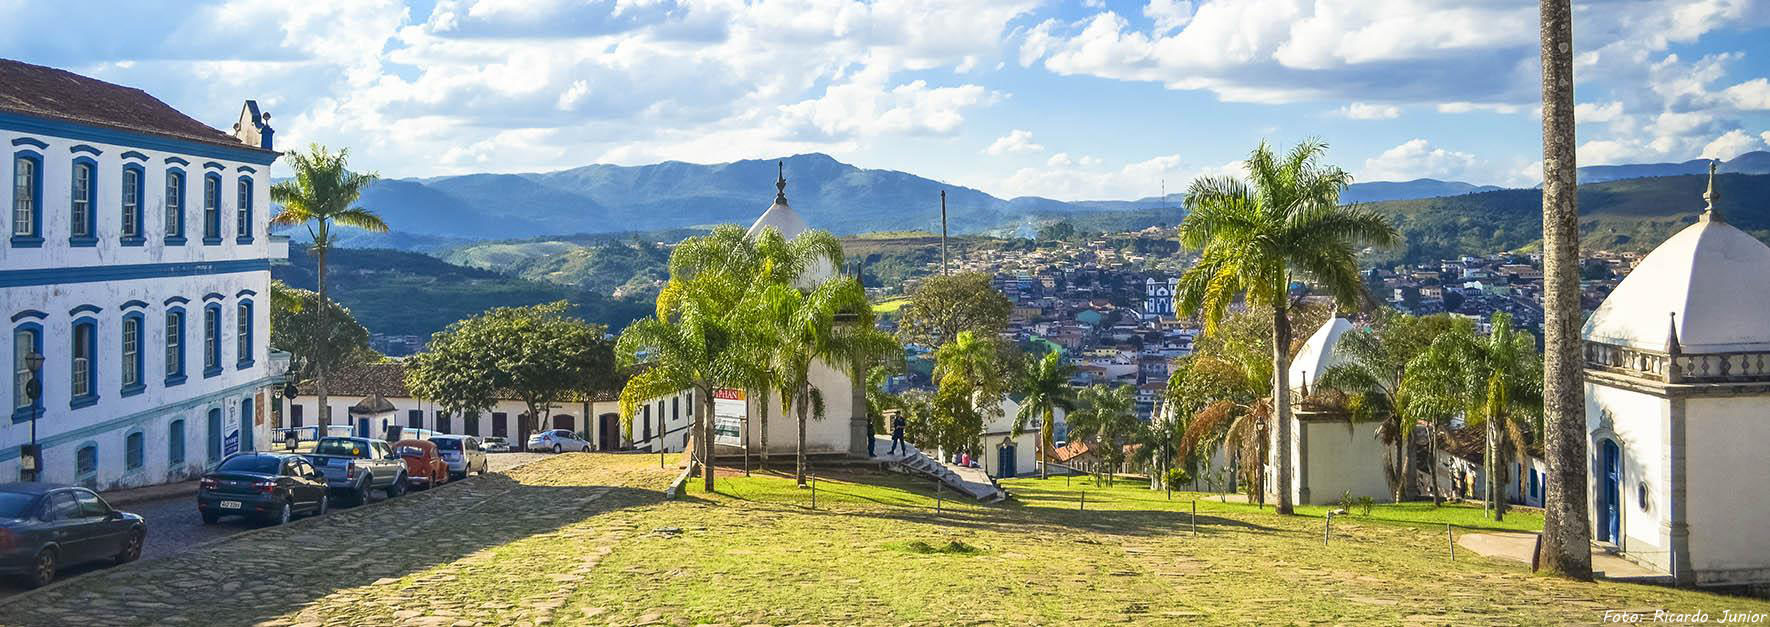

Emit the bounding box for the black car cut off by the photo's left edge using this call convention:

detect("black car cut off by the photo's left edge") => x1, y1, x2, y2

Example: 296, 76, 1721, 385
0, 482, 147, 588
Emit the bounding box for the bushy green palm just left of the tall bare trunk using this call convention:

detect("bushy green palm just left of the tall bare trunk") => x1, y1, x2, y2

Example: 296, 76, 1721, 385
1409, 312, 1543, 521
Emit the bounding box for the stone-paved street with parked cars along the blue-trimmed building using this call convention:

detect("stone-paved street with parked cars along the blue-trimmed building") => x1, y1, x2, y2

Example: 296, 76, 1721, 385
0, 453, 594, 625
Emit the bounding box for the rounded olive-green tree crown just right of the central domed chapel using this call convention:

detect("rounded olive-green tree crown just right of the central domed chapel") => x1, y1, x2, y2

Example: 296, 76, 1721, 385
897, 273, 1014, 347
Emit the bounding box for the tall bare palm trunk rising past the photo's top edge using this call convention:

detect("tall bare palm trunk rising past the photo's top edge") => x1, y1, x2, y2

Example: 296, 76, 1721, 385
1538, 0, 1591, 579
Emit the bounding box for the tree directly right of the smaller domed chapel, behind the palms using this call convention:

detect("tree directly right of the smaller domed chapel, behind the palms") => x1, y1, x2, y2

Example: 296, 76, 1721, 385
1315, 310, 1453, 503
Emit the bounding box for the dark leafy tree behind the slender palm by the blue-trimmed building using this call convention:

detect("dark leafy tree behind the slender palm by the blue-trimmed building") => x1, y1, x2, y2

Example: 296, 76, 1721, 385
271, 282, 381, 381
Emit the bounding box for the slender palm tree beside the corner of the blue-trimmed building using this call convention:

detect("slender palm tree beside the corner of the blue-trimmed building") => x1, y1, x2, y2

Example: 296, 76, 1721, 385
271, 143, 388, 430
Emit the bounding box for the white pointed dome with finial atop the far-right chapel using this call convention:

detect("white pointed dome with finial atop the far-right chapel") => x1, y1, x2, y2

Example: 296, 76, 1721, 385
1581, 166, 1770, 352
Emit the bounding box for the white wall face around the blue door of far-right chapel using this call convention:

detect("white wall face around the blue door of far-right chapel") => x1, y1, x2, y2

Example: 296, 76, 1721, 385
1586, 383, 1671, 570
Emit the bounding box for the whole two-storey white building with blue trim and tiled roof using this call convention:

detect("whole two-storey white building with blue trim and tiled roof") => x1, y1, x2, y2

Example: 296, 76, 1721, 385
0, 60, 287, 489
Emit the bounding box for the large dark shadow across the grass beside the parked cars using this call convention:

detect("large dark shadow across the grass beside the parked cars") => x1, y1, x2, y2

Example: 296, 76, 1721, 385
0, 460, 664, 625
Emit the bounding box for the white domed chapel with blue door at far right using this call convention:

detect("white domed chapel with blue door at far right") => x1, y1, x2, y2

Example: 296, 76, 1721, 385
1584, 166, 1770, 584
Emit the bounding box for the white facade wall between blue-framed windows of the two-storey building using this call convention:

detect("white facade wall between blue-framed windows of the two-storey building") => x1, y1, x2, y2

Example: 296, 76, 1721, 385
0, 128, 271, 489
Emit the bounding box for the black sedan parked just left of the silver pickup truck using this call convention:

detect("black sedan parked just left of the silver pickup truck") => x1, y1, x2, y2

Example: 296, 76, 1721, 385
196, 453, 331, 524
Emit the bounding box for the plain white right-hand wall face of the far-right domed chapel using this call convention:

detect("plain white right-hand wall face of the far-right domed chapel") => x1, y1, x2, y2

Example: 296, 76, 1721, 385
1685, 397, 1770, 581
